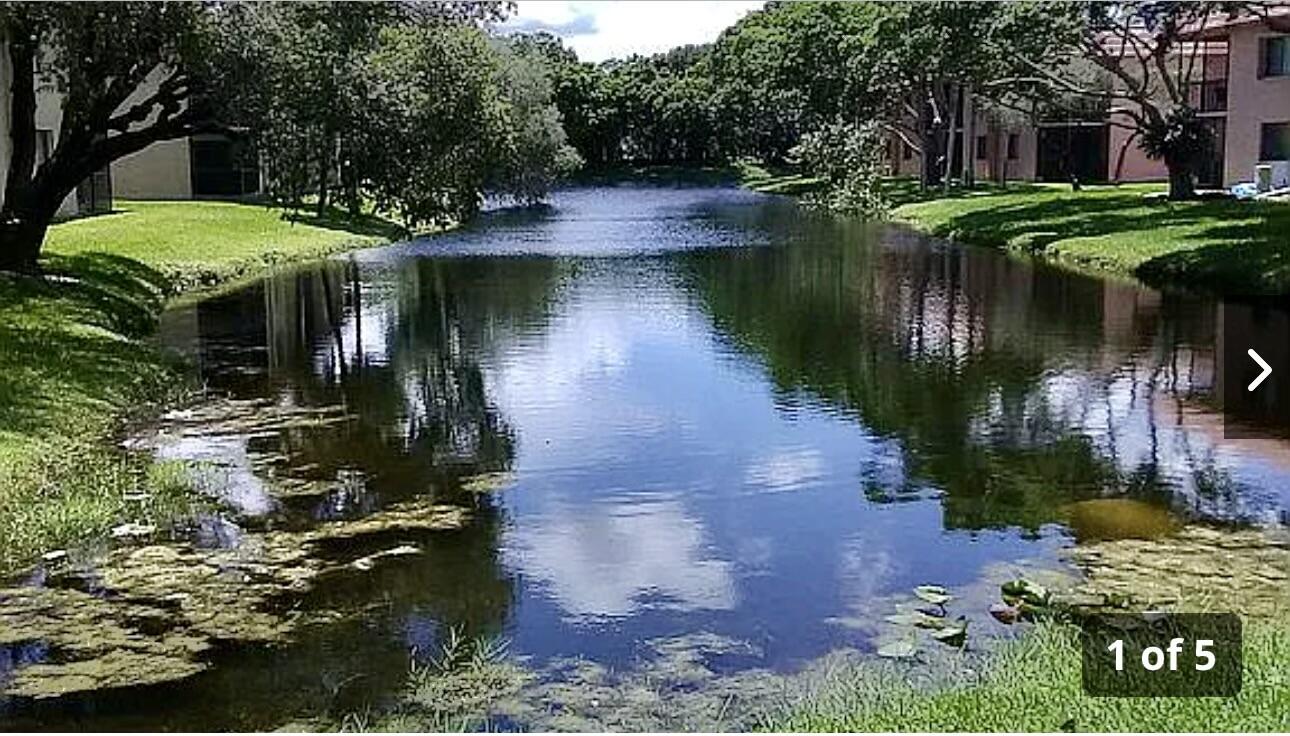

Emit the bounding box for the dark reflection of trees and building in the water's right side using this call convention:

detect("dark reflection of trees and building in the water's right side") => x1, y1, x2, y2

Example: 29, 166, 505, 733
685, 220, 1265, 531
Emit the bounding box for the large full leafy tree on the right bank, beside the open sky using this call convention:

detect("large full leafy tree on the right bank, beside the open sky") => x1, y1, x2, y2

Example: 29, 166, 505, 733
711, 1, 1073, 183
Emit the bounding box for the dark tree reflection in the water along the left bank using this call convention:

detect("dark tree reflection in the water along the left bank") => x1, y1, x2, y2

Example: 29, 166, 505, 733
143, 259, 559, 726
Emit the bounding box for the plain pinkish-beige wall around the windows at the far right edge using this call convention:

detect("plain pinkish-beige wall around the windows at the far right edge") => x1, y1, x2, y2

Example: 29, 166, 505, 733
1223, 23, 1290, 186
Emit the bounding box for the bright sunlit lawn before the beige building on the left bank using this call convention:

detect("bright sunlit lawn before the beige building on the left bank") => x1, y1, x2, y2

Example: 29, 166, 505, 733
45, 200, 399, 293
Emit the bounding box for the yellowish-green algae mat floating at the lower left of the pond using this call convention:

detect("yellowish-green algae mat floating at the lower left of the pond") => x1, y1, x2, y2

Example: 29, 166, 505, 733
0, 494, 468, 699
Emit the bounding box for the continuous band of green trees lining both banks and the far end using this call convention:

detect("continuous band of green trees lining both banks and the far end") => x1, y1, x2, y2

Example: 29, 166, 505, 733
0, 0, 1265, 268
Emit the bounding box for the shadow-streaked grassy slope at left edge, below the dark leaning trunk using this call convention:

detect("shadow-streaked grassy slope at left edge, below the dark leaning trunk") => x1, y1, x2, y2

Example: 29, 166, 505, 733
0, 254, 197, 572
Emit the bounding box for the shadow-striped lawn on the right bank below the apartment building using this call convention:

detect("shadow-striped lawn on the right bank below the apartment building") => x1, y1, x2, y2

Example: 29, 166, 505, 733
893, 184, 1290, 295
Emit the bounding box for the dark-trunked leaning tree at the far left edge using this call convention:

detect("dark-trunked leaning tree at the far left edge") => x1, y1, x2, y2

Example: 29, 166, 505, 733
0, 3, 243, 271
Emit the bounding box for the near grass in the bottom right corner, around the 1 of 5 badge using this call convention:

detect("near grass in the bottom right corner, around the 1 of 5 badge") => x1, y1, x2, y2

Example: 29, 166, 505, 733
766, 623, 1290, 732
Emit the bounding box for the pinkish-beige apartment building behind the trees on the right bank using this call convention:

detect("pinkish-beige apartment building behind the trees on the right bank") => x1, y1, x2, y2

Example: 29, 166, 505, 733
888, 10, 1290, 188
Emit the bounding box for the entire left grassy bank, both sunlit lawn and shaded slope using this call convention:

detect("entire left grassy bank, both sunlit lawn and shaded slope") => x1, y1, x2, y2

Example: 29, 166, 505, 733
0, 202, 395, 574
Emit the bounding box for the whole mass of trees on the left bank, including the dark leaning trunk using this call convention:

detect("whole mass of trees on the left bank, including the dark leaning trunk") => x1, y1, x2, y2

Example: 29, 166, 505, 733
0, 1, 577, 269
